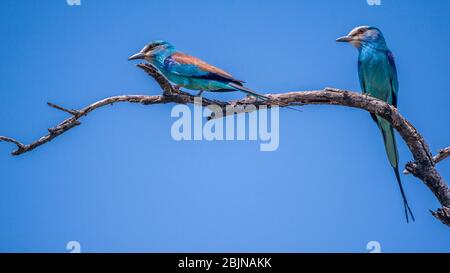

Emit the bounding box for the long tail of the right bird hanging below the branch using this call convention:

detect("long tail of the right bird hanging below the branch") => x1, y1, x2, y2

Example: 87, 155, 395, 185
373, 115, 415, 223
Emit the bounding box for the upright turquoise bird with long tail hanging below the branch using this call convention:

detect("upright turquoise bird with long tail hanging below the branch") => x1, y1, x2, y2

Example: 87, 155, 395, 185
336, 26, 414, 222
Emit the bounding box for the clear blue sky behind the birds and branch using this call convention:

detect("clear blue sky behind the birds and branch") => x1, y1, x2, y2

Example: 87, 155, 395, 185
0, 0, 450, 252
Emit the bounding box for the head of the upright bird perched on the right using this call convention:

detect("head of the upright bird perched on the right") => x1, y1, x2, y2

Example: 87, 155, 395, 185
336, 26, 386, 48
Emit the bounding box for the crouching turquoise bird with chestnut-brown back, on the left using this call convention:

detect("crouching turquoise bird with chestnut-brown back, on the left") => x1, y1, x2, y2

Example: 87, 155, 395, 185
129, 40, 272, 101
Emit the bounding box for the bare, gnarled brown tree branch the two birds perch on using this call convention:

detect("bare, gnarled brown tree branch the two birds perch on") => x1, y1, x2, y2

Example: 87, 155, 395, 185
0, 64, 450, 227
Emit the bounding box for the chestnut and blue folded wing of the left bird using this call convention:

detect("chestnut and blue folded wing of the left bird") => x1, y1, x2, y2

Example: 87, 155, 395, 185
164, 52, 243, 84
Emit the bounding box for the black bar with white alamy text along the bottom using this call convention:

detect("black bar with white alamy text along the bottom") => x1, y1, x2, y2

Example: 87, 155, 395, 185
0, 253, 444, 272
